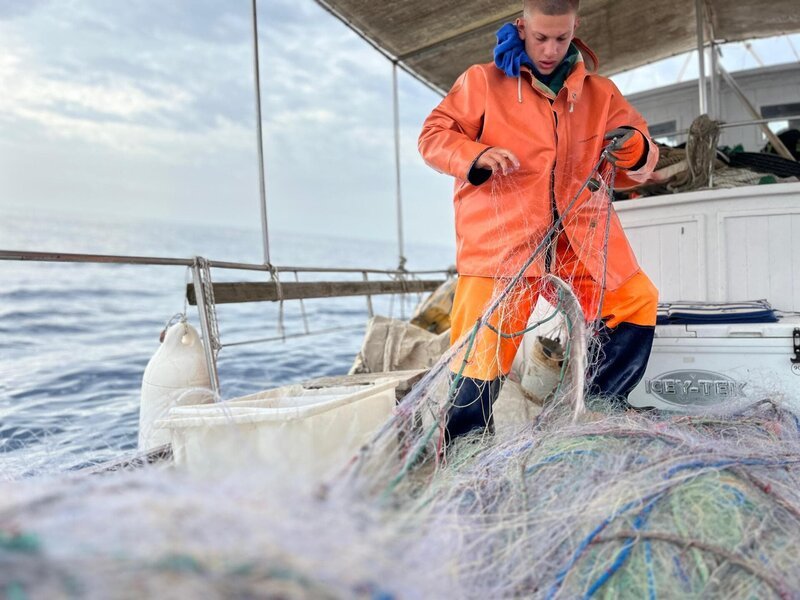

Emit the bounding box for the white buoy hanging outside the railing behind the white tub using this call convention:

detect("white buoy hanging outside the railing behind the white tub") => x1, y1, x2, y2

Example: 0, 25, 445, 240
139, 319, 214, 452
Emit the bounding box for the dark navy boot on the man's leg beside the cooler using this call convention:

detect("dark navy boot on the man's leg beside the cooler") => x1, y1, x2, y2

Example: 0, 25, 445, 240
588, 323, 656, 408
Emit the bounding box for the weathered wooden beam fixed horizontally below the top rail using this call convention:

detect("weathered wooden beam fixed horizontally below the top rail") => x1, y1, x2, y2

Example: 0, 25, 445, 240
186, 279, 444, 306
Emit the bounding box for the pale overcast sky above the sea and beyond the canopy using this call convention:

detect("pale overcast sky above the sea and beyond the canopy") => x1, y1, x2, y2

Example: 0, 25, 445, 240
0, 0, 800, 247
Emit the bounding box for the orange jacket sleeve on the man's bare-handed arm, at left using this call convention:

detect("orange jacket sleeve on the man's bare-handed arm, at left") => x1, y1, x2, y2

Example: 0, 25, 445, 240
417, 66, 491, 184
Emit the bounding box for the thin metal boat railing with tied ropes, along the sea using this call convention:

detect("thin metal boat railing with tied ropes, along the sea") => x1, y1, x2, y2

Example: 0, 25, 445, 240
0, 250, 454, 394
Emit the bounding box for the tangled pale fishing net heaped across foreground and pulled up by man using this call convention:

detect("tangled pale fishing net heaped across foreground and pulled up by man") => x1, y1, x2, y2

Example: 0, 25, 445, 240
0, 148, 800, 600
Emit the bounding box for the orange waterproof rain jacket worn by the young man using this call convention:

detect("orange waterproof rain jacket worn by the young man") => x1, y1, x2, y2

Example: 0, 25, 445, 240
419, 38, 658, 290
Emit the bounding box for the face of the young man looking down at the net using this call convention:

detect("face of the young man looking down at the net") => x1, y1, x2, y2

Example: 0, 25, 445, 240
516, 10, 578, 75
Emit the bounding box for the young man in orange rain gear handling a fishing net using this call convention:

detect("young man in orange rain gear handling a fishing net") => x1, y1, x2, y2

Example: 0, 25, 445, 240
419, 0, 658, 439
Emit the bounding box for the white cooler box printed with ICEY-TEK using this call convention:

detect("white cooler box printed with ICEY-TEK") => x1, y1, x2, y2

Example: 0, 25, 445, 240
629, 316, 800, 411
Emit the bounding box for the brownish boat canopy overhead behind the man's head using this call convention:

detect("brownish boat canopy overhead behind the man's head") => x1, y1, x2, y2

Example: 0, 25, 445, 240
317, 0, 800, 92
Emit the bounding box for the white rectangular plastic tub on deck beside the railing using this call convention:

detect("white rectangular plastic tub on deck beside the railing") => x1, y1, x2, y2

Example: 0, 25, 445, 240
157, 379, 398, 479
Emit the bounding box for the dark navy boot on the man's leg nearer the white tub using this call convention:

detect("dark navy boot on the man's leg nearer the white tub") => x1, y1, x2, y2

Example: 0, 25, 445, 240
445, 373, 501, 444
